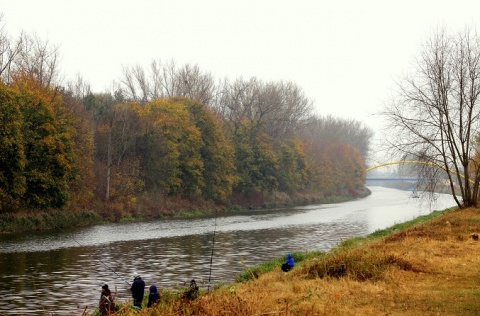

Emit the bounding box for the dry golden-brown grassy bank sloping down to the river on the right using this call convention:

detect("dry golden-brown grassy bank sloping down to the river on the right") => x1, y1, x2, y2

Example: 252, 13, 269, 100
93, 208, 480, 315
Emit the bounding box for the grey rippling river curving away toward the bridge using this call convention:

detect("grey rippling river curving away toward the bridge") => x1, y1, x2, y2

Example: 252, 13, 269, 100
0, 187, 455, 315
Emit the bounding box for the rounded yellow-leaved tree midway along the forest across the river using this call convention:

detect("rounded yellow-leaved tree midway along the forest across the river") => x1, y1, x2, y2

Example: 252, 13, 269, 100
139, 99, 204, 198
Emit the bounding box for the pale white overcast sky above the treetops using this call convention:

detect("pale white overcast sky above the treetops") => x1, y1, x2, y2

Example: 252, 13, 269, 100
0, 0, 480, 154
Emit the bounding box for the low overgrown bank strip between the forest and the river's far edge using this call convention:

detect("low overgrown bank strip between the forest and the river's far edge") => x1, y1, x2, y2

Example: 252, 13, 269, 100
0, 187, 371, 234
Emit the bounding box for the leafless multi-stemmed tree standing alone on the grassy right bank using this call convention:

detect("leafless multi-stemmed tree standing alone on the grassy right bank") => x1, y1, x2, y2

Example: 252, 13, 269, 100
383, 28, 480, 207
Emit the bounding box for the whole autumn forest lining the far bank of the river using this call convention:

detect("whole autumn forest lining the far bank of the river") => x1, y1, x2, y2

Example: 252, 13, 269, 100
0, 25, 373, 218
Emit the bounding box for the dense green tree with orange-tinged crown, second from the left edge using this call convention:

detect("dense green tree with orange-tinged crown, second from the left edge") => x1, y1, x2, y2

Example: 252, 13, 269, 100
12, 75, 76, 208
